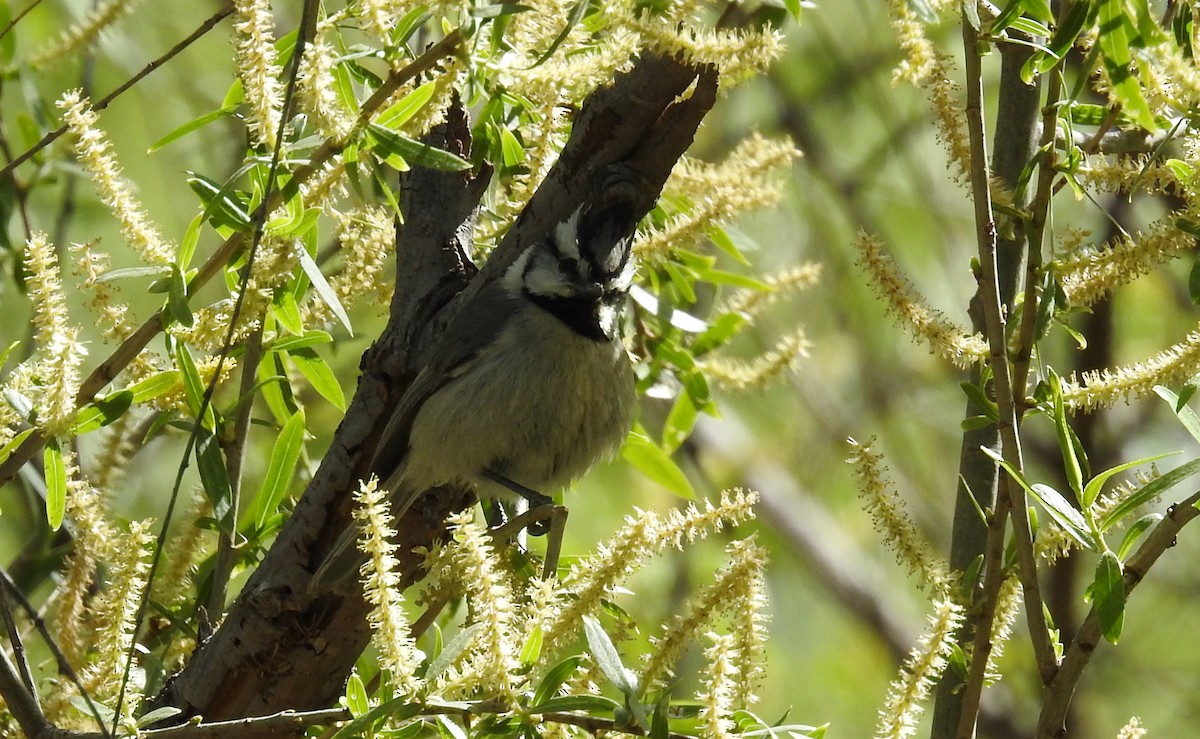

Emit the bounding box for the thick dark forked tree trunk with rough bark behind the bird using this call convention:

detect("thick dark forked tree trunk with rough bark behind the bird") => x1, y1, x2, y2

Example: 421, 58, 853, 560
155, 53, 716, 721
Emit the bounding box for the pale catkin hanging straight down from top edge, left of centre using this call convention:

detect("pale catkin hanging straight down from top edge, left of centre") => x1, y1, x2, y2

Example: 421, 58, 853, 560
233, 0, 283, 149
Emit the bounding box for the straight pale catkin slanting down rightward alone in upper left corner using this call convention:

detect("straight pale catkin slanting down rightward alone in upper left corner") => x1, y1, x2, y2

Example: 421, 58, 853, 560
58, 90, 175, 265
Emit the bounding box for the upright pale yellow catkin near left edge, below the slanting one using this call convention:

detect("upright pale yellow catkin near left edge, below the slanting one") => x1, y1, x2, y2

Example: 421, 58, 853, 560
25, 233, 86, 438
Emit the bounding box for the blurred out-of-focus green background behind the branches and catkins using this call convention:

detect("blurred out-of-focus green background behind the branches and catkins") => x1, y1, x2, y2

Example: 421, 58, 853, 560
7, 0, 1200, 737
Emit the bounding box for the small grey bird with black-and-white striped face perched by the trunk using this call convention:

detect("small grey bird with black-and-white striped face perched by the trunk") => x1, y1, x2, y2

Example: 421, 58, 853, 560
308, 184, 644, 593
